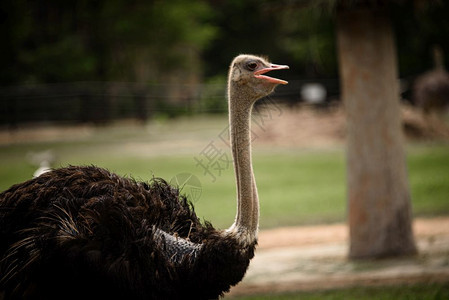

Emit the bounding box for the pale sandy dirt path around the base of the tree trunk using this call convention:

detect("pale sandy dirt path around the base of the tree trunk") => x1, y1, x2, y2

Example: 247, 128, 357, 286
227, 217, 449, 298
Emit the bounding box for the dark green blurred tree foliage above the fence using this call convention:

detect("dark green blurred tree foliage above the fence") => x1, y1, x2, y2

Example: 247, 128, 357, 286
0, 0, 449, 85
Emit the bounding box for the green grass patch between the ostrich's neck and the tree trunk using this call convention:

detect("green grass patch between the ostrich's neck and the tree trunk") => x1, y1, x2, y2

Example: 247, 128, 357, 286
254, 151, 345, 227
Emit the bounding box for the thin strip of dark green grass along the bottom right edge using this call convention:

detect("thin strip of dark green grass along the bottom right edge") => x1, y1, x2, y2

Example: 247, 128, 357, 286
231, 283, 449, 300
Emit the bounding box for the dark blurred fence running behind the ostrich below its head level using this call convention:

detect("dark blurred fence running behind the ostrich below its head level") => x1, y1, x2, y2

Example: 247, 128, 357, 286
0, 79, 339, 128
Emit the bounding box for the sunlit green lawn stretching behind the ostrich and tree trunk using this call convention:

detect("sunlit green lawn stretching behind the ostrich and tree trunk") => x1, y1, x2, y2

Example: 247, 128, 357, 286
0, 119, 449, 228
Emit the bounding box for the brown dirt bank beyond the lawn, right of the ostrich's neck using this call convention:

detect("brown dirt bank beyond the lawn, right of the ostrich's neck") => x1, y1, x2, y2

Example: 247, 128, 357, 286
252, 104, 449, 147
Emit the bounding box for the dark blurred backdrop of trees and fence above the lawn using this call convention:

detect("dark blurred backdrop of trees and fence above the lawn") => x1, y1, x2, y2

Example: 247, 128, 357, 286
0, 0, 449, 123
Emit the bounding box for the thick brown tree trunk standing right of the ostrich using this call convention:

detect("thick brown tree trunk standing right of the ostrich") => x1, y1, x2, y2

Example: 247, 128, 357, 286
337, 9, 416, 258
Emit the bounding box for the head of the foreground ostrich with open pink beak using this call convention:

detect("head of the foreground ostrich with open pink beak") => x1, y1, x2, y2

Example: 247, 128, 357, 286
228, 54, 289, 101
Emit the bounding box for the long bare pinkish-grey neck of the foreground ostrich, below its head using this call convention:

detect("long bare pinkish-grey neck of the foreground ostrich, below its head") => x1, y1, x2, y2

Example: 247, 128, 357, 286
228, 86, 259, 243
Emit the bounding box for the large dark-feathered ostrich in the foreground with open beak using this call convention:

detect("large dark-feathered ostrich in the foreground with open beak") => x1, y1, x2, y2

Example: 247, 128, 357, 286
0, 55, 288, 299
